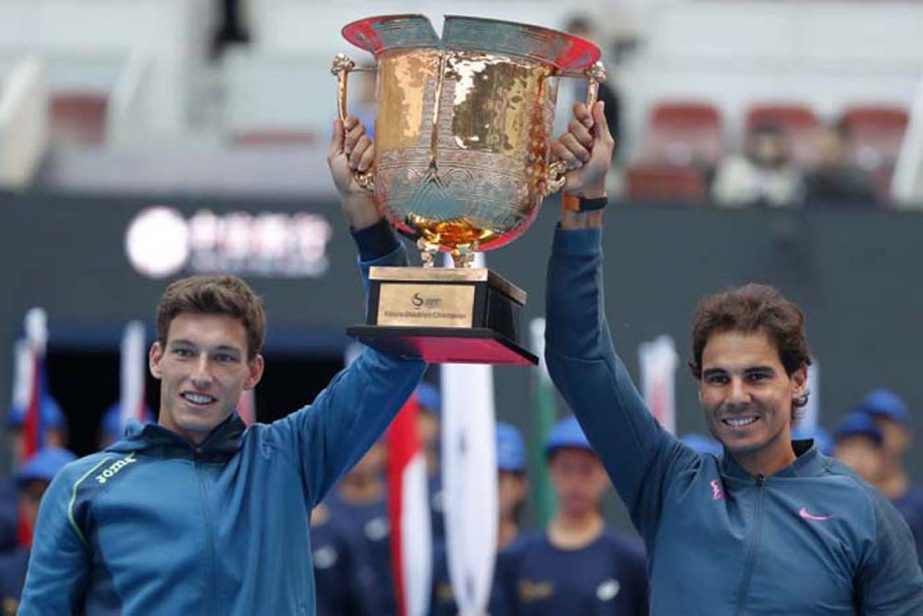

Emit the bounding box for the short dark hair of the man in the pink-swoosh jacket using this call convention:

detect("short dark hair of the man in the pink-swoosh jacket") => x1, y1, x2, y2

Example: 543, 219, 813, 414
689, 283, 811, 408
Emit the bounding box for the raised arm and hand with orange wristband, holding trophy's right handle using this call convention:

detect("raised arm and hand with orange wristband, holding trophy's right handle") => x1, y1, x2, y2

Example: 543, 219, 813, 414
545, 103, 695, 538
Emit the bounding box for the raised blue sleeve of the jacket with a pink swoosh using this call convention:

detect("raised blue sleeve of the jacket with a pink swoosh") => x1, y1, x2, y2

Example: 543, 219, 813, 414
545, 228, 698, 545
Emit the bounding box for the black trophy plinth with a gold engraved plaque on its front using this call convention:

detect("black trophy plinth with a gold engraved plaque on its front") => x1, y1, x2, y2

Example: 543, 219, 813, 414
346, 267, 538, 366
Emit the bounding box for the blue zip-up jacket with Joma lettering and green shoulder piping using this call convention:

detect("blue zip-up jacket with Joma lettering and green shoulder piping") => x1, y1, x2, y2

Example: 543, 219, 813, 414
20, 233, 425, 616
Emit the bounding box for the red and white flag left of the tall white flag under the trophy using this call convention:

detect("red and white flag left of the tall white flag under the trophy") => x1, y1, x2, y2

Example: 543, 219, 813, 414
385, 396, 432, 616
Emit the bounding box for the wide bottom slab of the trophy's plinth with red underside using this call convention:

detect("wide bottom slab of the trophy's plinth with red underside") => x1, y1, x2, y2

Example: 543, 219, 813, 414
346, 325, 538, 366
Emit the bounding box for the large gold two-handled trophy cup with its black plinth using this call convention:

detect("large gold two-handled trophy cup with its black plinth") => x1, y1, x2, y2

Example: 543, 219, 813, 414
332, 15, 605, 365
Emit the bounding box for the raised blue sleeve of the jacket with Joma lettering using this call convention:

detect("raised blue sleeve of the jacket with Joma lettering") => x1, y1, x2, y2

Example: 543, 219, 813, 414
269, 238, 426, 507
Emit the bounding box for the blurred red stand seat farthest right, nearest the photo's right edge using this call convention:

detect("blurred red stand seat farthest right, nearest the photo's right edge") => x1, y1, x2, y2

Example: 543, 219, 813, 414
842, 105, 910, 171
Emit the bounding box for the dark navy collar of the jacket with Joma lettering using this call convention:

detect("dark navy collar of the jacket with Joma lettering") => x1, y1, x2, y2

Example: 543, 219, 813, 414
107, 413, 247, 460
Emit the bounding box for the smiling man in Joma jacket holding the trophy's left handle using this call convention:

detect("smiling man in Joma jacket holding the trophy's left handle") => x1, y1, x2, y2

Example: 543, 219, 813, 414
19, 118, 425, 616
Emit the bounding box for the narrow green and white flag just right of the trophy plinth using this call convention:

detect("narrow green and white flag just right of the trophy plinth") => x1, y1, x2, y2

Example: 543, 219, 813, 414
529, 319, 558, 529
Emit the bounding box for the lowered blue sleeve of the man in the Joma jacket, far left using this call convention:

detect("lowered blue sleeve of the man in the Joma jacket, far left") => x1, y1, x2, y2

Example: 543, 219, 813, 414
19, 467, 90, 616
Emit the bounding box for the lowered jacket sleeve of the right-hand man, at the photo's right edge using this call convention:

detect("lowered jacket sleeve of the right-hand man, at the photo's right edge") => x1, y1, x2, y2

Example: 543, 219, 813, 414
856, 489, 923, 616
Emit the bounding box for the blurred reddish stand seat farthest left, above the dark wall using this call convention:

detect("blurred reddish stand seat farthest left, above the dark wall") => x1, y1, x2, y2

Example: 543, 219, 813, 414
51, 92, 109, 145
